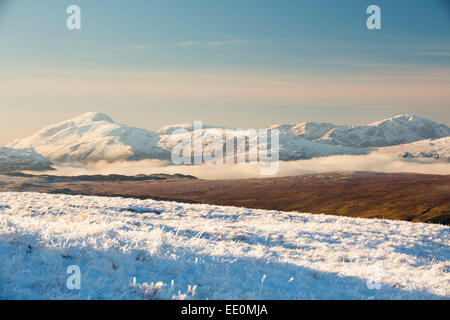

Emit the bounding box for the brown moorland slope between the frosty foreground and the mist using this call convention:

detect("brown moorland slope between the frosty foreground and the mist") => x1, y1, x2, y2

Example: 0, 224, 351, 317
0, 172, 450, 224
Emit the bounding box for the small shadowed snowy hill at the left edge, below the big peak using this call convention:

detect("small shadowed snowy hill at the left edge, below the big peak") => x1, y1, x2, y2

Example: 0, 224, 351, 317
0, 147, 52, 172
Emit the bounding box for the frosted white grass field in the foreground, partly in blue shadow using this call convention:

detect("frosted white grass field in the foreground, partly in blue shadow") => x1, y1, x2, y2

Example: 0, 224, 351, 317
0, 193, 450, 299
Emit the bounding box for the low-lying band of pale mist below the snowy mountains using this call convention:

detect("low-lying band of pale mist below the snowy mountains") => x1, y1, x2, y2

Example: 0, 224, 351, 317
32, 153, 450, 179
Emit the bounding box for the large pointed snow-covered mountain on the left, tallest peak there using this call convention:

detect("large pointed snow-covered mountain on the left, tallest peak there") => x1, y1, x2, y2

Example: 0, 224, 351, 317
7, 112, 170, 162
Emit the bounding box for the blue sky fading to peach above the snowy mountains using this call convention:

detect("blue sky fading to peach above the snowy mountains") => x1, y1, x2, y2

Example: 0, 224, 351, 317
0, 0, 450, 145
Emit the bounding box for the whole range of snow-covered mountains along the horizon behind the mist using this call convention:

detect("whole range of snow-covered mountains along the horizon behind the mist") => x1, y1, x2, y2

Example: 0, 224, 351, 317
0, 112, 450, 170
